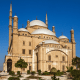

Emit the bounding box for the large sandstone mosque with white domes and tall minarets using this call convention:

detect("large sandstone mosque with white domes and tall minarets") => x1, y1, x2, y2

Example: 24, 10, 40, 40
3, 4, 76, 73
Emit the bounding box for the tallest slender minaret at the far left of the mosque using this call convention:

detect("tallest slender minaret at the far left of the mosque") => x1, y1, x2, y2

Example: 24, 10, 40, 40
9, 3, 12, 46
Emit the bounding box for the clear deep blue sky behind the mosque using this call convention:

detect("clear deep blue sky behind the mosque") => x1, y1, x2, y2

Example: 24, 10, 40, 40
0, 0, 80, 70
